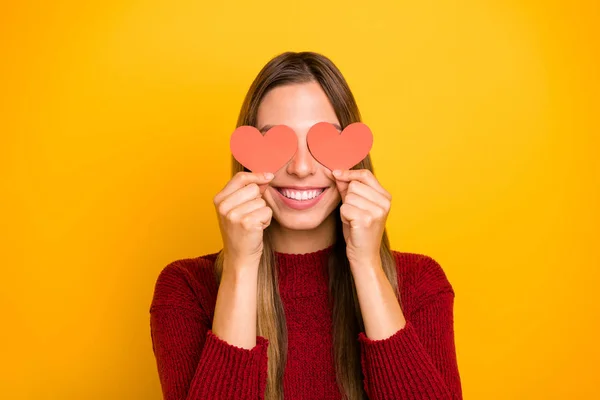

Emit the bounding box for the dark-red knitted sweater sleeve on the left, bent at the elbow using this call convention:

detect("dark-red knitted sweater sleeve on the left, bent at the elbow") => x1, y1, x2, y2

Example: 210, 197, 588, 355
150, 266, 268, 400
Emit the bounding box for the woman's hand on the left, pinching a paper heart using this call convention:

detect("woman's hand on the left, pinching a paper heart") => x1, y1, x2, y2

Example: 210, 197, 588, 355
213, 172, 273, 265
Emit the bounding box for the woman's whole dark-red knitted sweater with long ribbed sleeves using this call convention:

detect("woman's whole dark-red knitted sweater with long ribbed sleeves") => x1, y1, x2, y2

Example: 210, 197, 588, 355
150, 247, 462, 400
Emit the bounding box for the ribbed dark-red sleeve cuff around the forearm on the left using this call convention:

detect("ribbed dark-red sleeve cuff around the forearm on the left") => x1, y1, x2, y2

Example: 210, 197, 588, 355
189, 330, 269, 399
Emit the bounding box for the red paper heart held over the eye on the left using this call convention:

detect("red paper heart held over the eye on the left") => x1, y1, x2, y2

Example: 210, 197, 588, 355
229, 125, 298, 173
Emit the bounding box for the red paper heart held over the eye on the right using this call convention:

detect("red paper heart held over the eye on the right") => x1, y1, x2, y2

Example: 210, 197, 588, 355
306, 122, 373, 170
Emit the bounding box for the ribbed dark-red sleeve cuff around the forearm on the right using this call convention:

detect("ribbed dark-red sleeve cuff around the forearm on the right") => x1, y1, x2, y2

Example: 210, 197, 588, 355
358, 321, 451, 400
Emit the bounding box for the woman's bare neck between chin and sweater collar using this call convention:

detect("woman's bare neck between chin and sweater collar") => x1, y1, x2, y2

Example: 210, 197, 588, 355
270, 213, 336, 254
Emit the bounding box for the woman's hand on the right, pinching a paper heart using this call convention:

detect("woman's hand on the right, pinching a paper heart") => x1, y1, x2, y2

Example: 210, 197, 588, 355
333, 169, 392, 266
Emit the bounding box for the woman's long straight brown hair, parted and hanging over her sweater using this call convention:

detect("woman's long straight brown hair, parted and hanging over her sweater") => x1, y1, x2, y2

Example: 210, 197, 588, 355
215, 52, 400, 400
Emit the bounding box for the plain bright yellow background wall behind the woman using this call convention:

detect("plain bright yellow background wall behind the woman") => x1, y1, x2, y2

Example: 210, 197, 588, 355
0, 0, 600, 399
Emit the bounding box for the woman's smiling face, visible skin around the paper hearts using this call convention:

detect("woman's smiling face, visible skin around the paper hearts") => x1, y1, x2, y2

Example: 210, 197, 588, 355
257, 82, 341, 230
